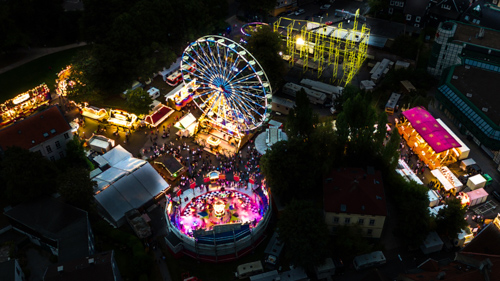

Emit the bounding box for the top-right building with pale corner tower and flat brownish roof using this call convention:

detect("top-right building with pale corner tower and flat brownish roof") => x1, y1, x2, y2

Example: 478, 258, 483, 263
427, 21, 500, 77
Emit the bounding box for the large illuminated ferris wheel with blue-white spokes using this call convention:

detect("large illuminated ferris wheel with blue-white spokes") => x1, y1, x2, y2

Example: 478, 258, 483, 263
181, 35, 272, 132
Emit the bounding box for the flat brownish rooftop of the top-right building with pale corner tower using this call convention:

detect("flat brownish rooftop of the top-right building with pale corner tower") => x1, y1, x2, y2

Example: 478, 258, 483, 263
454, 22, 500, 50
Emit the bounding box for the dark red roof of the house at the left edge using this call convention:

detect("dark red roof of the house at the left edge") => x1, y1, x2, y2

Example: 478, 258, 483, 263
0, 105, 71, 150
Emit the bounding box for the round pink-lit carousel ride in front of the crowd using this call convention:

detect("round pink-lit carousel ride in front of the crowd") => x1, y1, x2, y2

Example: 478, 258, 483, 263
165, 171, 271, 256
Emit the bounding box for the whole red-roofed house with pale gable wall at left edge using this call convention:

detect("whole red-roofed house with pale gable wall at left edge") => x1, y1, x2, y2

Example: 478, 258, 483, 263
0, 105, 73, 161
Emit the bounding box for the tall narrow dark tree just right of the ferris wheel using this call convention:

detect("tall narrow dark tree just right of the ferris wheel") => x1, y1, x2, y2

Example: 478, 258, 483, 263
286, 89, 317, 139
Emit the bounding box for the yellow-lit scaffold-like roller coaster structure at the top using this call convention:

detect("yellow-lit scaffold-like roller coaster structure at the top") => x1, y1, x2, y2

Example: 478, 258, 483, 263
273, 9, 370, 86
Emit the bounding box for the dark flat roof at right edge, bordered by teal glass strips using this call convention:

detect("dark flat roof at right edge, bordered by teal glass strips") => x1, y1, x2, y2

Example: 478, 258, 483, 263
450, 65, 500, 125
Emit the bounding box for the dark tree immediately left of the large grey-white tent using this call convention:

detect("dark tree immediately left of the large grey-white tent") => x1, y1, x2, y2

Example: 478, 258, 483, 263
57, 167, 97, 211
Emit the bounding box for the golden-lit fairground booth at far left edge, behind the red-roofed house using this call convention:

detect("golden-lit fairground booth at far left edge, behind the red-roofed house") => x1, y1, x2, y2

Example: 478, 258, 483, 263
0, 83, 50, 126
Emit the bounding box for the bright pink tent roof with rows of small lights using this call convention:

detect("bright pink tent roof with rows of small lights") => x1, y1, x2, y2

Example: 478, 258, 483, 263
403, 107, 460, 153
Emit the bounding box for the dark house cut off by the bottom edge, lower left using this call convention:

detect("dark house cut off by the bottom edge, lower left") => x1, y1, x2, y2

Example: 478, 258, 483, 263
43, 250, 122, 281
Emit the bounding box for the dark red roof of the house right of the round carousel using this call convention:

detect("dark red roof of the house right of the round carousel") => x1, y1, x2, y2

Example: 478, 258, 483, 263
323, 168, 387, 216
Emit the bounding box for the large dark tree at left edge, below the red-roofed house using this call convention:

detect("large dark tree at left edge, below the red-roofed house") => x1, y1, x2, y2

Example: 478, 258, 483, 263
0, 147, 58, 204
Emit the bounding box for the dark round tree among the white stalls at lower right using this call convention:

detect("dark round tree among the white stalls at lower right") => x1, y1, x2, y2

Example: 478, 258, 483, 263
436, 197, 467, 239
